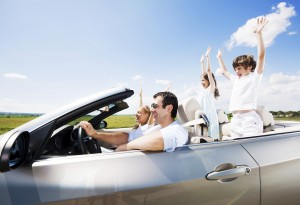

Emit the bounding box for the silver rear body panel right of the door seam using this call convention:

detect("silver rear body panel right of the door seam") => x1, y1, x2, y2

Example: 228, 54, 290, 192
242, 132, 300, 205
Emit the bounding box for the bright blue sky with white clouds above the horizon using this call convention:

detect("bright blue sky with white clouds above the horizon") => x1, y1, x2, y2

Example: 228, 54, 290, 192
0, 0, 300, 113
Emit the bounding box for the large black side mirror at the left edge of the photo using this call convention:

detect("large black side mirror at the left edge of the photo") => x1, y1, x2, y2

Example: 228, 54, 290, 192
0, 131, 30, 172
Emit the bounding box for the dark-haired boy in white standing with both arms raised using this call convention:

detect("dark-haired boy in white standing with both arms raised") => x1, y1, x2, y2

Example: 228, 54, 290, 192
217, 18, 267, 138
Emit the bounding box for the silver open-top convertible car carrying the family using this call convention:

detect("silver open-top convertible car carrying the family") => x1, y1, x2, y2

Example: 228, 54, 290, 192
0, 87, 300, 205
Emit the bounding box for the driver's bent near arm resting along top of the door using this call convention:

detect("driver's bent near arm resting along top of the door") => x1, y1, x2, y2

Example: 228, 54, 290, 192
116, 130, 164, 151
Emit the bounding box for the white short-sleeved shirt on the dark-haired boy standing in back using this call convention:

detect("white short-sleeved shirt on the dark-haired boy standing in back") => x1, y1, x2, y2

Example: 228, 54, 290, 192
229, 70, 262, 112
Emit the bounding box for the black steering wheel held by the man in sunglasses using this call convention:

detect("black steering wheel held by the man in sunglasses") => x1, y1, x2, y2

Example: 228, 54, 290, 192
77, 127, 101, 154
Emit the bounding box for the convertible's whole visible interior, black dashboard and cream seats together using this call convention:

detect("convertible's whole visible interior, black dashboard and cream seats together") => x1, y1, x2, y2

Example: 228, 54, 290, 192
41, 97, 298, 158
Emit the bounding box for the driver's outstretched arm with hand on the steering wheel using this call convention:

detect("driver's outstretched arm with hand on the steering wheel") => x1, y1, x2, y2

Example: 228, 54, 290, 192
79, 121, 129, 146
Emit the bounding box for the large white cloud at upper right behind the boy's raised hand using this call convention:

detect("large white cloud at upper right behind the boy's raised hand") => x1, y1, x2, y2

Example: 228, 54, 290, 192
226, 2, 296, 50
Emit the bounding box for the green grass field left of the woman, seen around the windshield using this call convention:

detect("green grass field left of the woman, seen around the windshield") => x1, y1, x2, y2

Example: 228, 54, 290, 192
0, 115, 135, 135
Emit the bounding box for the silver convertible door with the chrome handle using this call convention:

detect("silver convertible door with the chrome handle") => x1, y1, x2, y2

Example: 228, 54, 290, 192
32, 142, 260, 205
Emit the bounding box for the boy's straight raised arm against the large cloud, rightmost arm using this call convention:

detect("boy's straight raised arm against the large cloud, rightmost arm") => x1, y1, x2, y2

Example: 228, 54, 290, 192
253, 17, 268, 74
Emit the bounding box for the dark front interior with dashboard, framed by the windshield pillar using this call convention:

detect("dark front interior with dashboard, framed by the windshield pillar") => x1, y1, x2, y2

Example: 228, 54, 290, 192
41, 100, 128, 158
